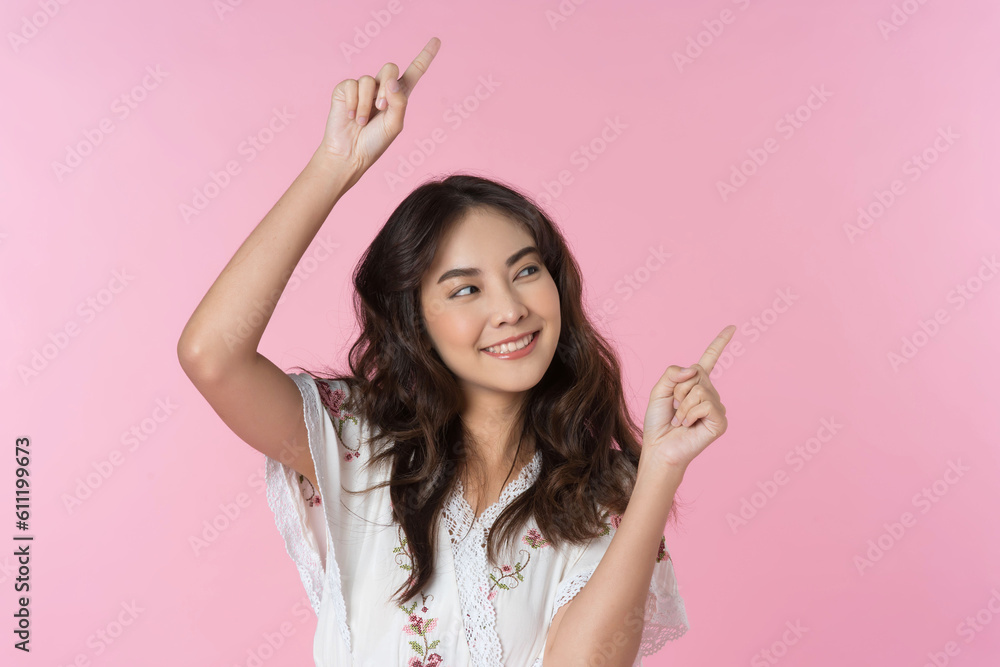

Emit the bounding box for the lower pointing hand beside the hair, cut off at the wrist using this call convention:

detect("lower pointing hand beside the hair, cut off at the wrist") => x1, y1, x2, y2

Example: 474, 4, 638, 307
639, 324, 736, 473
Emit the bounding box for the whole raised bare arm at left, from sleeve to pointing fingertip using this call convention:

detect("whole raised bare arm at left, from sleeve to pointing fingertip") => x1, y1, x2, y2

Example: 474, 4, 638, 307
177, 38, 440, 488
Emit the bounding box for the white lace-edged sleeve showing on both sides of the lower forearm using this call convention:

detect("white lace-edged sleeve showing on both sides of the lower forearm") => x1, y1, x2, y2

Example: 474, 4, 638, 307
550, 515, 690, 667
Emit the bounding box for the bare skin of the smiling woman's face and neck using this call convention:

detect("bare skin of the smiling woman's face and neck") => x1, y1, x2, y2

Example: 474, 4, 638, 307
420, 209, 561, 514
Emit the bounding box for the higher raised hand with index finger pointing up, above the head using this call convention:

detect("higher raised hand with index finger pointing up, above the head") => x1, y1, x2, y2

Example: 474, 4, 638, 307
318, 37, 441, 183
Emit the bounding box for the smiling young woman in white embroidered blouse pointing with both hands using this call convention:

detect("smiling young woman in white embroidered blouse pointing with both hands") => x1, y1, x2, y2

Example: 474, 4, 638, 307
178, 38, 735, 667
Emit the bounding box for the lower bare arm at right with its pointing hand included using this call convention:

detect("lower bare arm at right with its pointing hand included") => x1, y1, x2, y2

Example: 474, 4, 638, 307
545, 325, 736, 667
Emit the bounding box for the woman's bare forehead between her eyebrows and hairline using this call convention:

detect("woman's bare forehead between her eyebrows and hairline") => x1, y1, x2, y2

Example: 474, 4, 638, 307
424, 209, 534, 282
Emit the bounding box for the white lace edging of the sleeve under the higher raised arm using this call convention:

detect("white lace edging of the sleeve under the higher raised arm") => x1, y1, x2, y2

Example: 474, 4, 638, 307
264, 374, 351, 652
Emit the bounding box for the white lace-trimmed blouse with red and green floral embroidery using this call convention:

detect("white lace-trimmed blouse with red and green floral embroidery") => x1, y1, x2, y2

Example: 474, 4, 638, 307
265, 373, 688, 667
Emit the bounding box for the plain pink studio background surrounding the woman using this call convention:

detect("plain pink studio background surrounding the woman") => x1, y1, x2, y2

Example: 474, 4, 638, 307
0, 0, 1000, 667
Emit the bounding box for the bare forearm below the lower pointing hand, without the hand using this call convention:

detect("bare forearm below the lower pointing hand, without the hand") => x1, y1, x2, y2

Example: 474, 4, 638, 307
545, 466, 684, 667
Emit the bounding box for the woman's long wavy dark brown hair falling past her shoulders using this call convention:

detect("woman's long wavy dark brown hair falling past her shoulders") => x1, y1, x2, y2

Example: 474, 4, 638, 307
300, 174, 678, 603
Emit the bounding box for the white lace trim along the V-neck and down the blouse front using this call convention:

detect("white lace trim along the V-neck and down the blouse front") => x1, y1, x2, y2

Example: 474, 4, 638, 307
443, 451, 542, 667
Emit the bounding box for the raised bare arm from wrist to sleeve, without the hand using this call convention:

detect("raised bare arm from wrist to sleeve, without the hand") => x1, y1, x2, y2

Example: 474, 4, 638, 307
177, 150, 353, 486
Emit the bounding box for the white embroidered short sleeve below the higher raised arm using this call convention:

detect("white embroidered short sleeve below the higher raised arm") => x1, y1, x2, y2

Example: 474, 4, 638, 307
264, 373, 358, 642
